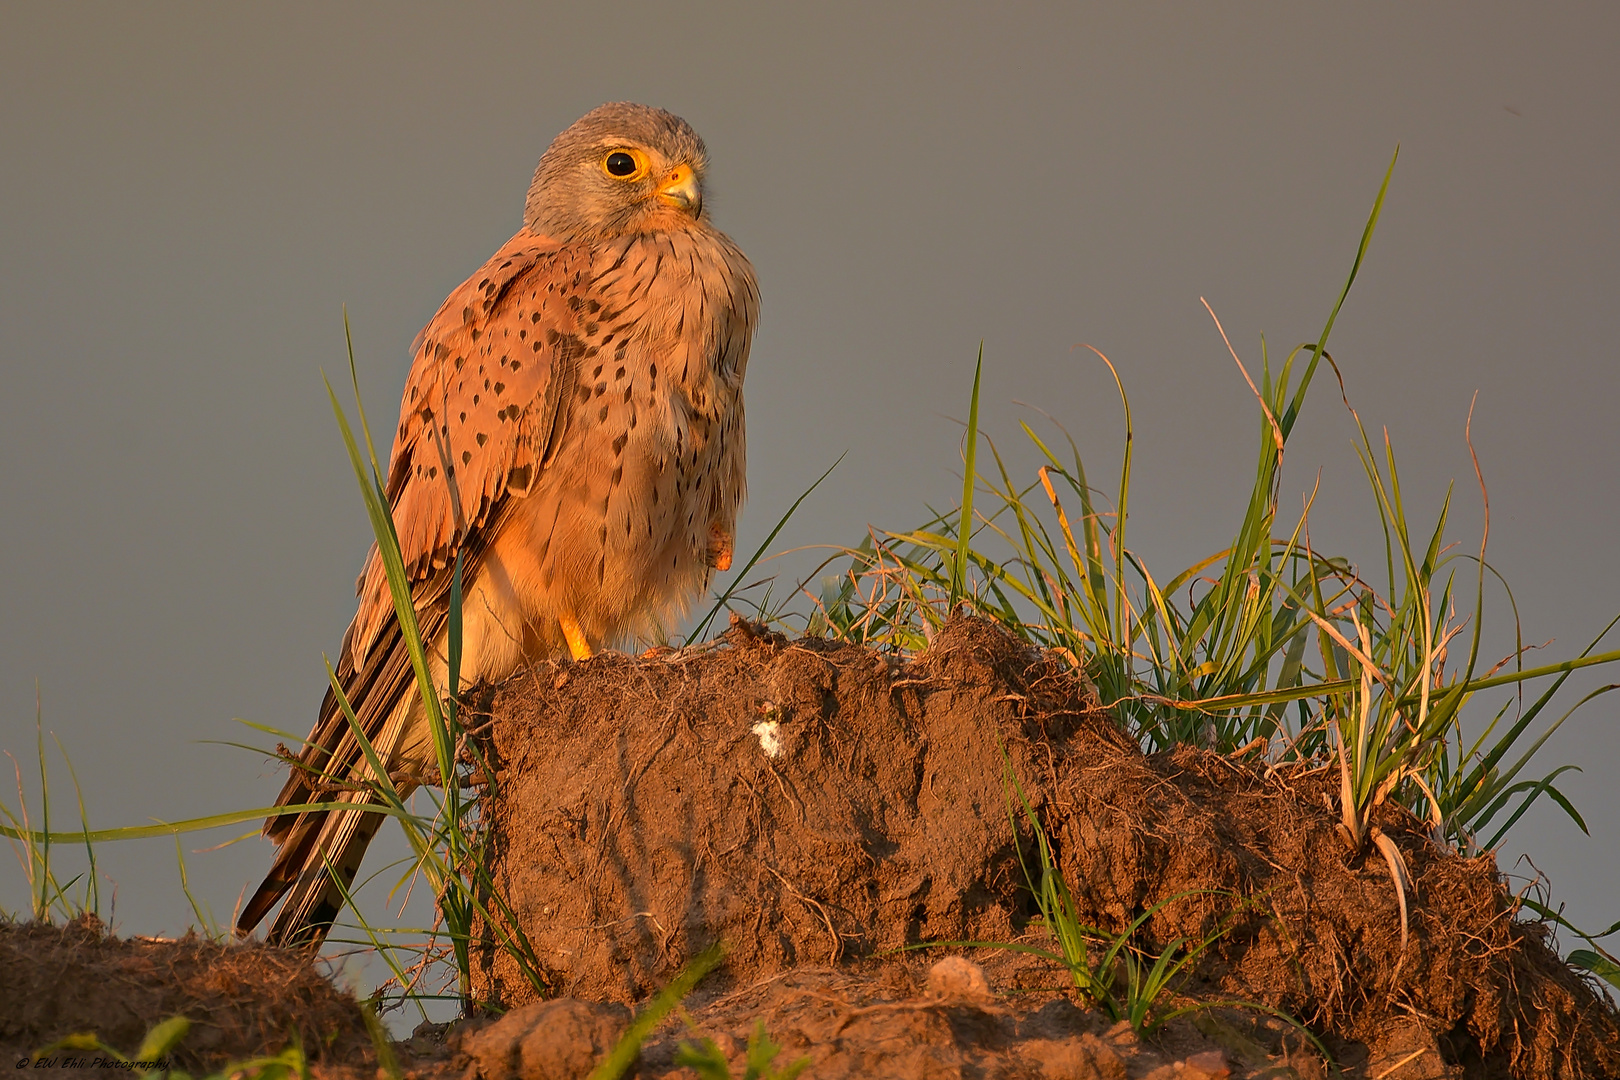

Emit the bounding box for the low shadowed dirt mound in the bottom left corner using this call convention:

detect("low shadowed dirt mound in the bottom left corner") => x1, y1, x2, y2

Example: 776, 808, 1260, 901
0, 915, 371, 1074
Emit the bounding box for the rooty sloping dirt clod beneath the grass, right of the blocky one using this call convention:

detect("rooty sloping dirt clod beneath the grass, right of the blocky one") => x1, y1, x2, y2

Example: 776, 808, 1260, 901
1048, 731, 1620, 1077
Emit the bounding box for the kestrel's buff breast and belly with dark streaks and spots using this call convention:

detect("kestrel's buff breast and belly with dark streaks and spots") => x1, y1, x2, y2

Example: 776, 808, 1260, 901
486, 233, 758, 641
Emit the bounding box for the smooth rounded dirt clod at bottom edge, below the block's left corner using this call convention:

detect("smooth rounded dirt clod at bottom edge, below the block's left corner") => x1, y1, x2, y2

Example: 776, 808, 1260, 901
460, 997, 630, 1080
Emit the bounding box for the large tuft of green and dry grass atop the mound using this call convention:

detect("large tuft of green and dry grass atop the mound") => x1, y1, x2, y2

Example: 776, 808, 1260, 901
793, 151, 1620, 906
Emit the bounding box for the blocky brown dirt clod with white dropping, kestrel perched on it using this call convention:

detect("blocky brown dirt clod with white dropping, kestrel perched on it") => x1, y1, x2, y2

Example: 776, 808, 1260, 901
463, 623, 1108, 1002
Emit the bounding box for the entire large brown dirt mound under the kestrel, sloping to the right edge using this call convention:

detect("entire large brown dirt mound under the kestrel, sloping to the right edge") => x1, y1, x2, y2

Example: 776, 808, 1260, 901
476, 619, 1620, 1077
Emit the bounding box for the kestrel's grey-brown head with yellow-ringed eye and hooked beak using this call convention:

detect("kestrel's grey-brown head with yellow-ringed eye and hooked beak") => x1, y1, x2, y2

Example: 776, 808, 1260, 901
523, 102, 708, 243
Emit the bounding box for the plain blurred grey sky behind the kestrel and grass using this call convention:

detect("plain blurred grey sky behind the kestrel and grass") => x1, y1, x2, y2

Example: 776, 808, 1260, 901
0, 3, 1620, 977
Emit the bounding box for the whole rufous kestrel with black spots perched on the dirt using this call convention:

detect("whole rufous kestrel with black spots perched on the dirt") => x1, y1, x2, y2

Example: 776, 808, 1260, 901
237, 102, 760, 947
